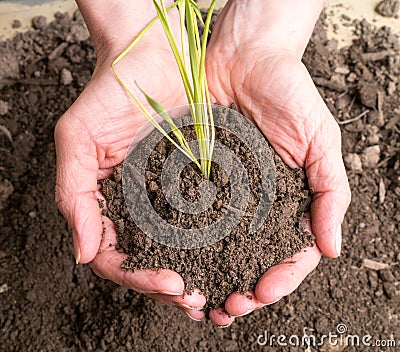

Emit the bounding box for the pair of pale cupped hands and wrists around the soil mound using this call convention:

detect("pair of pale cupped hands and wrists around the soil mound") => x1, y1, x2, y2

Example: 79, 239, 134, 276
55, 0, 350, 326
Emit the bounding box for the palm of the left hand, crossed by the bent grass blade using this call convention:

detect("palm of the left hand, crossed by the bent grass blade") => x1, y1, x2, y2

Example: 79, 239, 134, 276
72, 47, 188, 169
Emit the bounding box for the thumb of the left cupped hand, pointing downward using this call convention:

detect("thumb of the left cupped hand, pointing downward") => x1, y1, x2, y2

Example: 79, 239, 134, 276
55, 113, 102, 263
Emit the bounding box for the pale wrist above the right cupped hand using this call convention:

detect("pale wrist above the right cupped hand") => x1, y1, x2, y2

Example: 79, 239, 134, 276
212, 0, 327, 59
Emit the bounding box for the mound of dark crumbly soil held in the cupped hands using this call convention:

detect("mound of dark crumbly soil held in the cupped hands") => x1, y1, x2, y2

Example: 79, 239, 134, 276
102, 107, 312, 308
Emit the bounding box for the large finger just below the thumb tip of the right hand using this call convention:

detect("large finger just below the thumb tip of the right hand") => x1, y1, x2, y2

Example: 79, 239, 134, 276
254, 246, 321, 304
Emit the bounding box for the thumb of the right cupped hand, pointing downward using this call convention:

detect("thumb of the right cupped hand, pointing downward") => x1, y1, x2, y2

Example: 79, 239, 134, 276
305, 114, 351, 258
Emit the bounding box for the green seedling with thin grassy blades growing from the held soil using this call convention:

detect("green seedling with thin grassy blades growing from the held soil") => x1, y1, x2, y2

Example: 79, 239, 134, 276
111, 0, 216, 179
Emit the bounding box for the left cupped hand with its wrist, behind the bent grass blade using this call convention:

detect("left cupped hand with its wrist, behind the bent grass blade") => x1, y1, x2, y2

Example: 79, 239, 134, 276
55, 0, 205, 319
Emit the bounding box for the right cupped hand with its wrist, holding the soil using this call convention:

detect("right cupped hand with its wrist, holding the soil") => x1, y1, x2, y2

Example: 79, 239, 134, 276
207, 0, 350, 326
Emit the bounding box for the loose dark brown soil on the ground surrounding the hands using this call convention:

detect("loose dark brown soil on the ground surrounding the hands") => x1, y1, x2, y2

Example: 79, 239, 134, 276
0, 8, 400, 351
